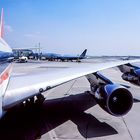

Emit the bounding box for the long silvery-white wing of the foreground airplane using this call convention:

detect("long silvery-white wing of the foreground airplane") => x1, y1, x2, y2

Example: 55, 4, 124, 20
3, 60, 140, 108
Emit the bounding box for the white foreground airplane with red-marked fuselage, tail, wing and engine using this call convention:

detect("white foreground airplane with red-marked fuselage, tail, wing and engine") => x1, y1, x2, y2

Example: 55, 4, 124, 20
0, 9, 140, 117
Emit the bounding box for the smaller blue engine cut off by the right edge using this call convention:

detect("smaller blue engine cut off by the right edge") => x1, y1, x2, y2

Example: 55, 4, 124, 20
122, 69, 140, 86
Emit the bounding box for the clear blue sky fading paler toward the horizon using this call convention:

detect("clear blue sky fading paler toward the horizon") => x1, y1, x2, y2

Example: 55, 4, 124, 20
0, 0, 140, 56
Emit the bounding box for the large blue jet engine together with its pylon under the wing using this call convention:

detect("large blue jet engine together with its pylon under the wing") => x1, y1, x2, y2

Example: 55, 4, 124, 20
87, 73, 133, 116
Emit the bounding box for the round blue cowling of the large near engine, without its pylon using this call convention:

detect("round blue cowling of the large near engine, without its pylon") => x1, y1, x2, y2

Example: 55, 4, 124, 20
94, 84, 133, 116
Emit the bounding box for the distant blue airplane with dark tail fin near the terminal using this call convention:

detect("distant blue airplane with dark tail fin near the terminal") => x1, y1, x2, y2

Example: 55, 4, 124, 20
41, 49, 87, 62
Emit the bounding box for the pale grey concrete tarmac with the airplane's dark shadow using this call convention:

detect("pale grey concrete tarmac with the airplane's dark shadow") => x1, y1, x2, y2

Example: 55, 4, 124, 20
0, 59, 140, 140
